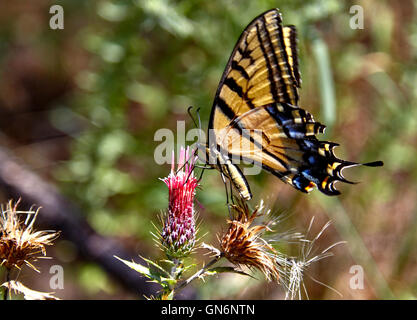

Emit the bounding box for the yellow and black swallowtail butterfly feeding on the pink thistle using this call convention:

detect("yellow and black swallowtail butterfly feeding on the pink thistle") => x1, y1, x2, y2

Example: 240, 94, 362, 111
206, 9, 383, 200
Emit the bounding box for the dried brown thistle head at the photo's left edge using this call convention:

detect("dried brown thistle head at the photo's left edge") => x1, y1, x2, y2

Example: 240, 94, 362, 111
0, 200, 59, 272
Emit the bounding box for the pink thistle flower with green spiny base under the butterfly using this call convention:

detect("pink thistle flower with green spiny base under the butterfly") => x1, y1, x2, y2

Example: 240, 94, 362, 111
161, 147, 198, 259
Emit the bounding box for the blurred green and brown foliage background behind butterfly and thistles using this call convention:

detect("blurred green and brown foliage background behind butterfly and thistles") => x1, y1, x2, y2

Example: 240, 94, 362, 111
0, 0, 417, 299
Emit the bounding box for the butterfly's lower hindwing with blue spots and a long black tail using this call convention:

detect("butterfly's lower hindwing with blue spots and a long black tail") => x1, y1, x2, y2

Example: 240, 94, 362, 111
221, 103, 382, 195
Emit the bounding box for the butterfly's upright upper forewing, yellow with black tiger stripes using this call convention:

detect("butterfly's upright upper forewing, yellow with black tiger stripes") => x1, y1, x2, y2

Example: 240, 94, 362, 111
209, 9, 300, 138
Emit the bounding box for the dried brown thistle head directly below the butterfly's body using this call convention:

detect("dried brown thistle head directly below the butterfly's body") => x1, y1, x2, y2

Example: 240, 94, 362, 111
220, 200, 279, 281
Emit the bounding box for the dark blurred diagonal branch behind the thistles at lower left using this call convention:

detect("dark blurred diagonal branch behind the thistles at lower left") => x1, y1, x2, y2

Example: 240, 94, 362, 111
0, 147, 168, 298
